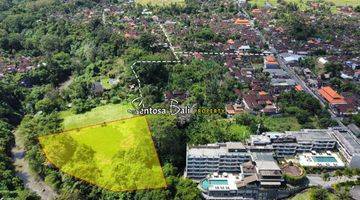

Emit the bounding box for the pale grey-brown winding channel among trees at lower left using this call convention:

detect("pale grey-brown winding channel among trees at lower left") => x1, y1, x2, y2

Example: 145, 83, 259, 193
11, 131, 57, 200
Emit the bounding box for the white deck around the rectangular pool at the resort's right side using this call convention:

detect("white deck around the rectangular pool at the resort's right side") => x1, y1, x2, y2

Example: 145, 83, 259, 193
299, 153, 345, 168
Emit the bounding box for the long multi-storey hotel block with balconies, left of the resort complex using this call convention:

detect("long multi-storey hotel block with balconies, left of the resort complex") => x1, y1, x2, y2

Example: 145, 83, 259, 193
185, 142, 251, 180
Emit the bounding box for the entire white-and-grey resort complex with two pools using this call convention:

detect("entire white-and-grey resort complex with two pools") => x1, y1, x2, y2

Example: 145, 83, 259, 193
185, 128, 360, 200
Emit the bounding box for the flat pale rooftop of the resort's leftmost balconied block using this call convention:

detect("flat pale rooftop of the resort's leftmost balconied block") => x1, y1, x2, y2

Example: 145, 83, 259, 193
188, 142, 246, 157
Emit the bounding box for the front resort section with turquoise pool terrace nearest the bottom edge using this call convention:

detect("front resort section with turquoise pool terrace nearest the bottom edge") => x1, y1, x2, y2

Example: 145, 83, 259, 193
199, 153, 283, 200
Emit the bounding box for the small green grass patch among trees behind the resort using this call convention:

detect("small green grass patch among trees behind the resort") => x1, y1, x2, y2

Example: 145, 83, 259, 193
264, 117, 301, 132
